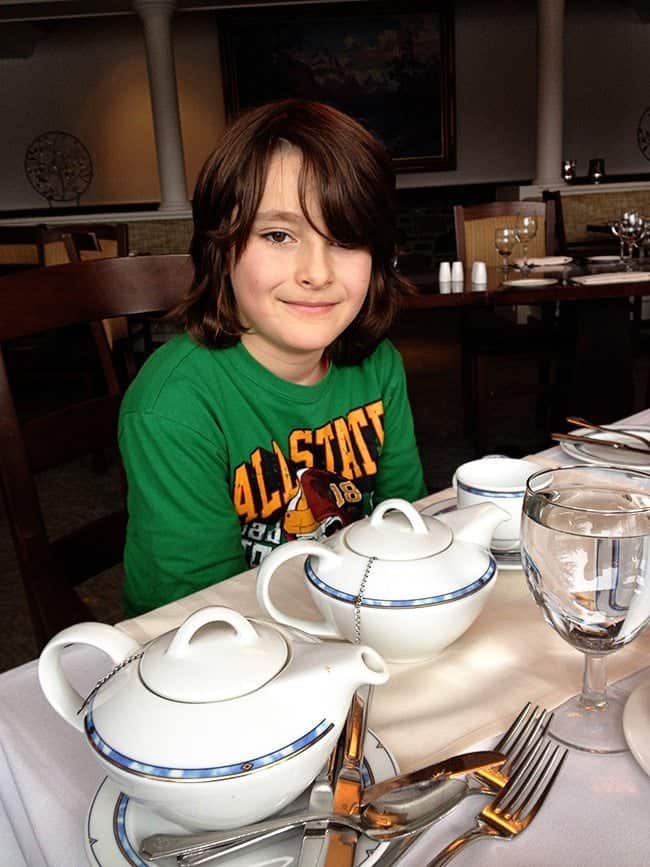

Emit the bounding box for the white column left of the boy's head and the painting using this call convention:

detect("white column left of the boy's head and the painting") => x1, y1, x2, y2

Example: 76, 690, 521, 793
133, 0, 189, 213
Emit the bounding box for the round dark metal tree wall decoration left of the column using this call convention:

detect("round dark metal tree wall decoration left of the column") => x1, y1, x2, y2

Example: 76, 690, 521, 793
25, 130, 93, 207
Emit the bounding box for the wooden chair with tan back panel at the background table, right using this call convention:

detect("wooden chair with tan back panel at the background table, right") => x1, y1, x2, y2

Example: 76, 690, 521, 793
454, 201, 557, 454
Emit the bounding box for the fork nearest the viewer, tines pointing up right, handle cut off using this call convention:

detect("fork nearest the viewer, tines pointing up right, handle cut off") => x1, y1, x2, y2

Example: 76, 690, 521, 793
426, 739, 569, 867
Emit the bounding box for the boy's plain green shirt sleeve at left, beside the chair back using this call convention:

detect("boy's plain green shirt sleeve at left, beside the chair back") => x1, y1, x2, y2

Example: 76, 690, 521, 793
119, 411, 248, 616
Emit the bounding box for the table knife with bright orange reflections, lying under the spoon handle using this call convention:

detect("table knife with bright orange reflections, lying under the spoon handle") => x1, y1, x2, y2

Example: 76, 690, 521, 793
325, 685, 373, 867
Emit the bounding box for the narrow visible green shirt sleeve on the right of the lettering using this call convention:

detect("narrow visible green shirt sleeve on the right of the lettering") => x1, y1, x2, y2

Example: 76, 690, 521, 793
375, 341, 426, 505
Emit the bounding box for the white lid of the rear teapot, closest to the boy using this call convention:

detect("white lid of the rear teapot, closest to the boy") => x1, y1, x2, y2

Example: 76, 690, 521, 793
345, 499, 453, 561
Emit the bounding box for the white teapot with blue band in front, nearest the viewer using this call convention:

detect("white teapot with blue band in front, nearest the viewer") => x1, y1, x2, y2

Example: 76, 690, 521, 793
38, 606, 388, 830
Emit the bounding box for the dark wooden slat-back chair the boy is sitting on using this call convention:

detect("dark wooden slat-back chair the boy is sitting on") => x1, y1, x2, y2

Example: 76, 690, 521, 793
0, 255, 192, 647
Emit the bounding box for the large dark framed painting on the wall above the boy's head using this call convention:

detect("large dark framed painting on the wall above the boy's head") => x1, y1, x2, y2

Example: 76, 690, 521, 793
218, 0, 455, 172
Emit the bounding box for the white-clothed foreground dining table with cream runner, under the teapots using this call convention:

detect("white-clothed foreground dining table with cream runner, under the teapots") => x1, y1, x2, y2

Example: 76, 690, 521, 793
0, 409, 650, 867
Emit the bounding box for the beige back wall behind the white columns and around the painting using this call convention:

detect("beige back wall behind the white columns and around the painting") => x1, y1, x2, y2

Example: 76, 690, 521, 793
0, 0, 650, 210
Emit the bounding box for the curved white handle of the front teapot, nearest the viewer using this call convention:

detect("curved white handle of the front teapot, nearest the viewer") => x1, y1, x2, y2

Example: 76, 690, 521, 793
38, 623, 142, 731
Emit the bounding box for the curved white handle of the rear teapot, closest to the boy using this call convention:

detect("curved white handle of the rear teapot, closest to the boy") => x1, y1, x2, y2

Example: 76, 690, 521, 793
257, 539, 342, 638
